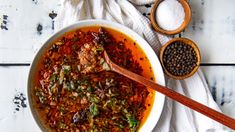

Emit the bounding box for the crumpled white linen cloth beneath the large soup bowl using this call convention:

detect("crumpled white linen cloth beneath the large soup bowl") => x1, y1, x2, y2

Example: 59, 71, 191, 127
57, 0, 226, 132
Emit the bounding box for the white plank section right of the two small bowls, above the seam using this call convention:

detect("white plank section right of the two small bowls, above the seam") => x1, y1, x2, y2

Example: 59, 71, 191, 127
183, 0, 235, 63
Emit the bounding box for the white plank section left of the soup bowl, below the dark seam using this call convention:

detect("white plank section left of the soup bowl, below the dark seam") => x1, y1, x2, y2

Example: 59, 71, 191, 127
0, 66, 40, 132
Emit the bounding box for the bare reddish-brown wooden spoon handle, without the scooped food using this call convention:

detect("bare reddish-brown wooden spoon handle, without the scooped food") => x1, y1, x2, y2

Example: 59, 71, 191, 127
104, 51, 235, 129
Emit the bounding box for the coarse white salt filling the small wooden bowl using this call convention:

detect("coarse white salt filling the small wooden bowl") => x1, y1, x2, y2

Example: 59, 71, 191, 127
155, 0, 185, 31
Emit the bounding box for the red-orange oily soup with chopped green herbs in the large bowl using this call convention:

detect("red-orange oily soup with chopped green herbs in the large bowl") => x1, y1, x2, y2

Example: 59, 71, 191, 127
34, 26, 154, 131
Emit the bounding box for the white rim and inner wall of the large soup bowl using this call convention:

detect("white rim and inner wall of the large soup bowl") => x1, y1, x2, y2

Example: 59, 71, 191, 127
28, 20, 165, 132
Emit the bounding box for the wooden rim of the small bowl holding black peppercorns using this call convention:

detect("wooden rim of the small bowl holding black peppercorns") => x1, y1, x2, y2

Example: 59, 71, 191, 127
159, 38, 201, 80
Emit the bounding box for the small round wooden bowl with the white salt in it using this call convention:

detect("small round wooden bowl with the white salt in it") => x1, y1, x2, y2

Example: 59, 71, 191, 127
150, 0, 191, 35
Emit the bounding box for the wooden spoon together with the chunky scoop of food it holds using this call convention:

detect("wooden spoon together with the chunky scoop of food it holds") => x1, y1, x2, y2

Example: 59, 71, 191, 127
78, 43, 235, 129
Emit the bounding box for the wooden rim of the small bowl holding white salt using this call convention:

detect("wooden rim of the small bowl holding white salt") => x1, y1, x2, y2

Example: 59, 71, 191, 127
150, 0, 192, 35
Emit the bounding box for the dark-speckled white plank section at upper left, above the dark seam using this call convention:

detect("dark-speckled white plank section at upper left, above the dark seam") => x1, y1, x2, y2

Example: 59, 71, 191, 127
0, 0, 61, 63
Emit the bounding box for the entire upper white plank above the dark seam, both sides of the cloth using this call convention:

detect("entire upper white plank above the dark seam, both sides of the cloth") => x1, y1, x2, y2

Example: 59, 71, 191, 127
0, 0, 235, 63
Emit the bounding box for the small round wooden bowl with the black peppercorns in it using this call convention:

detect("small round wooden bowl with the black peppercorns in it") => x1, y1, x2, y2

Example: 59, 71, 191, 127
160, 38, 201, 80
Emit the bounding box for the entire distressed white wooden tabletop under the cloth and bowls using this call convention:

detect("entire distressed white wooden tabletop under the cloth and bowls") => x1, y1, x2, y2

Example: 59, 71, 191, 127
0, 0, 235, 132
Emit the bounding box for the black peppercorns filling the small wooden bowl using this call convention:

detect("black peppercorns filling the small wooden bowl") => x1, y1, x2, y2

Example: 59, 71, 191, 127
162, 40, 198, 76
